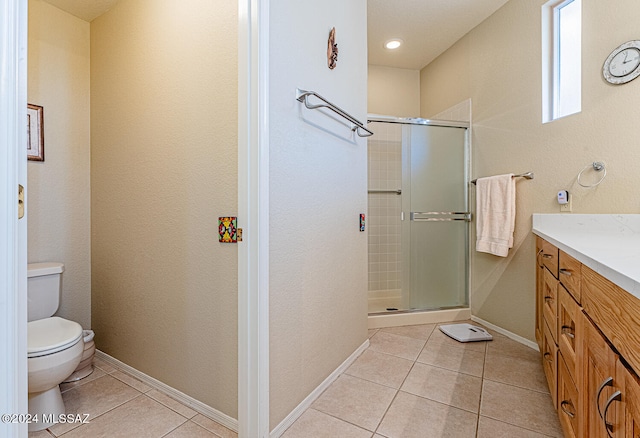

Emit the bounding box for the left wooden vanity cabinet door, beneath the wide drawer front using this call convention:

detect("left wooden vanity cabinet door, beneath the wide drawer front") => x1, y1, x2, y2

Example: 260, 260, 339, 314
580, 317, 623, 438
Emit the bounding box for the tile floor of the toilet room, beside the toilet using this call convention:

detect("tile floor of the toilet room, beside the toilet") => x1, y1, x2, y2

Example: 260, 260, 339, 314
29, 358, 238, 438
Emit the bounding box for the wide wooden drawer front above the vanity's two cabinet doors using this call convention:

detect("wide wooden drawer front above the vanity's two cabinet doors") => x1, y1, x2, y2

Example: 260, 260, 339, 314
582, 265, 640, 374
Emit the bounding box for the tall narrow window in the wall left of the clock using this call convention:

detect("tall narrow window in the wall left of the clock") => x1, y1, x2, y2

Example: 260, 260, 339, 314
542, 0, 582, 123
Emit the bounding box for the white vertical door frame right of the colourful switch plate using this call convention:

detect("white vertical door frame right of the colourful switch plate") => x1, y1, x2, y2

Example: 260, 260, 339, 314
238, 0, 270, 438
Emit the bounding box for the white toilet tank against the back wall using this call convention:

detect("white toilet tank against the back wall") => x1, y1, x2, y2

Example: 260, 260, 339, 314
27, 262, 64, 321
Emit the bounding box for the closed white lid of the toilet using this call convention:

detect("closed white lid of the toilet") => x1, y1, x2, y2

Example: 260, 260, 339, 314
27, 316, 82, 357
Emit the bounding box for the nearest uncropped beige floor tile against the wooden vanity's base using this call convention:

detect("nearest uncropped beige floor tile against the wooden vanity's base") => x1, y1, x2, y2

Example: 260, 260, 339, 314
480, 380, 562, 438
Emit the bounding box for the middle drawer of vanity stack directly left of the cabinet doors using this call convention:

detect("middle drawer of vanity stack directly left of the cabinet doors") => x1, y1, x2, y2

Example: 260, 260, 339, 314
558, 284, 583, 382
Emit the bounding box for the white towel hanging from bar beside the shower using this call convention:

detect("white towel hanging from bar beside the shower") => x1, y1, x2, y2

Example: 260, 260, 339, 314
476, 173, 516, 257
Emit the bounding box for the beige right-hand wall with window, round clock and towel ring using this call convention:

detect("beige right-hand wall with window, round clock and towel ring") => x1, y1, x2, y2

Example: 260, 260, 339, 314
421, 0, 640, 340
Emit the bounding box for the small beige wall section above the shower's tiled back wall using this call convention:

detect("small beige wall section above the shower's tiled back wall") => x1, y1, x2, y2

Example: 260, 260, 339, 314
367, 65, 420, 117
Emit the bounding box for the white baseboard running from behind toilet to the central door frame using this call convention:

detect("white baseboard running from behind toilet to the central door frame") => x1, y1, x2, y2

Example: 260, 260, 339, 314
96, 350, 238, 432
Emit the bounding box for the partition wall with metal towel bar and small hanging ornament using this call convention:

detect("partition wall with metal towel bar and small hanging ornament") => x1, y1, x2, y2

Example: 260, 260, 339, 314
269, 0, 367, 429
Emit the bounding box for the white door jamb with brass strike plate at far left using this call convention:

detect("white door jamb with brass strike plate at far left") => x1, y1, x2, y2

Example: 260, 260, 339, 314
0, 0, 28, 437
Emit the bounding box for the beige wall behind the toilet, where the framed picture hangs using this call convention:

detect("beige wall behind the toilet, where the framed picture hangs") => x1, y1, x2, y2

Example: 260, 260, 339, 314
27, 0, 91, 329
